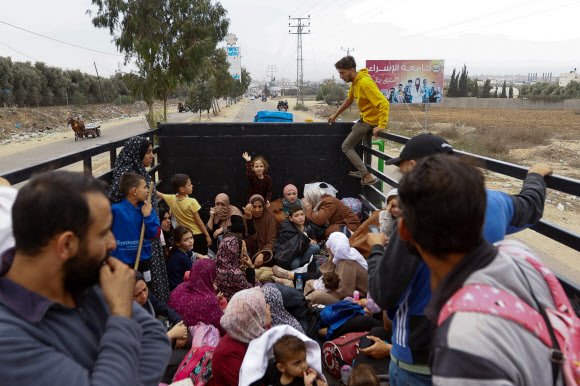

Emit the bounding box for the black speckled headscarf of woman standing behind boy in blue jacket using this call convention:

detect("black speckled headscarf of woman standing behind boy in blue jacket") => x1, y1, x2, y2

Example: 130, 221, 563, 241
109, 136, 157, 205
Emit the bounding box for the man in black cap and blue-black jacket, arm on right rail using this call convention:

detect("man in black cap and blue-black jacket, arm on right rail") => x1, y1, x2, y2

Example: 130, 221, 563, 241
367, 134, 552, 386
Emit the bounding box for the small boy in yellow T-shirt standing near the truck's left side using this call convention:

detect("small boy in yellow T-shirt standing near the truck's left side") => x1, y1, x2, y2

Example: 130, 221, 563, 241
157, 174, 212, 255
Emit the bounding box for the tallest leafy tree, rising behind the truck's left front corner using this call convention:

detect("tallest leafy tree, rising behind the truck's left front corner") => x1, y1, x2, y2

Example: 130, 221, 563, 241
91, 0, 229, 125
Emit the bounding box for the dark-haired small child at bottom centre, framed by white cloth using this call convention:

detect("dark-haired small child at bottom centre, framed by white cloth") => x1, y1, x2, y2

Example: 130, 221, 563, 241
262, 335, 326, 386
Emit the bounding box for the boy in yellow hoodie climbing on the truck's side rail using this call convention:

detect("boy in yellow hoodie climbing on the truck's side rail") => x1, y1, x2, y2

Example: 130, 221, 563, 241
328, 55, 389, 185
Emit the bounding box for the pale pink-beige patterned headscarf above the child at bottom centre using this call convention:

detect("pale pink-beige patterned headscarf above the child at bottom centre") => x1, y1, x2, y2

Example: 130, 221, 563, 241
220, 288, 268, 343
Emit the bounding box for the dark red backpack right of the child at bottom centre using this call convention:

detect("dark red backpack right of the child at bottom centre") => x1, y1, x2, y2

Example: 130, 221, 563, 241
322, 331, 368, 379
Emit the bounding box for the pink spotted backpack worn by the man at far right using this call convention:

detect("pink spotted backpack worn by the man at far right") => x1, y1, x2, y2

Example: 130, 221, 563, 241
437, 242, 580, 386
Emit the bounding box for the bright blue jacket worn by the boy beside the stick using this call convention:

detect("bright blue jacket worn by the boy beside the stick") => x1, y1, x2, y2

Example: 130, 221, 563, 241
111, 198, 161, 264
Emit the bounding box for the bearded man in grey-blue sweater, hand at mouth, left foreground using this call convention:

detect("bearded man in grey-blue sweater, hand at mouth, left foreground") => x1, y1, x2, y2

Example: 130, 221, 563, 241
0, 171, 171, 385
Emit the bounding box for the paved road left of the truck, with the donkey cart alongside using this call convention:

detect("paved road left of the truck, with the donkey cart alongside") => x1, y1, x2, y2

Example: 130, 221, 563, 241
0, 108, 193, 174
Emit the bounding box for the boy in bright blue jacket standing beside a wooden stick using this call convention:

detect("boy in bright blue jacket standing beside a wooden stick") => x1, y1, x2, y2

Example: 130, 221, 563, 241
111, 173, 161, 282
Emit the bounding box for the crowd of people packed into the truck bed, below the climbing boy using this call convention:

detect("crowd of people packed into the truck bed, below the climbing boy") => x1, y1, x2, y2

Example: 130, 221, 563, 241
0, 130, 555, 385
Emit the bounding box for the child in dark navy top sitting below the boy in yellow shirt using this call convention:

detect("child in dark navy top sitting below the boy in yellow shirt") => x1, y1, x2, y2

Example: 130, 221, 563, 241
167, 225, 207, 291
